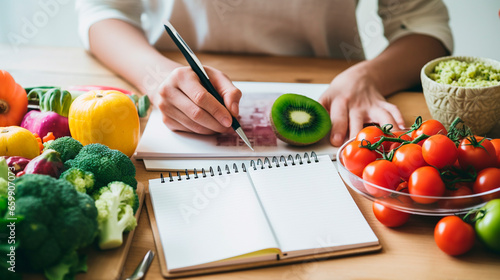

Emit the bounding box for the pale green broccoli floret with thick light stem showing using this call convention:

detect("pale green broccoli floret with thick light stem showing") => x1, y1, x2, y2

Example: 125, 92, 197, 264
94, 181, 138, 250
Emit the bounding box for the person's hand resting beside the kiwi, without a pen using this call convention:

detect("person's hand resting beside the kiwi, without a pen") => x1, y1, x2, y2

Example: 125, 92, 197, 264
319, 63, 405, 146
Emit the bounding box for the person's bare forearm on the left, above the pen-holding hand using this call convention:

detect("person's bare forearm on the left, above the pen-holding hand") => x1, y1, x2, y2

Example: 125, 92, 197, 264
89, 19, 180, 95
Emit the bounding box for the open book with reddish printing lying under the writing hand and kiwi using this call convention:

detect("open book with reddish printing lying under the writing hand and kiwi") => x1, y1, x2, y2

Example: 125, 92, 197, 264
135, 82, 337, 171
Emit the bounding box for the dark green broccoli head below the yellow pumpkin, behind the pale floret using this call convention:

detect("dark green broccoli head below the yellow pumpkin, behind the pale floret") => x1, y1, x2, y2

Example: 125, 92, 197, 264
66, 143, 137, 189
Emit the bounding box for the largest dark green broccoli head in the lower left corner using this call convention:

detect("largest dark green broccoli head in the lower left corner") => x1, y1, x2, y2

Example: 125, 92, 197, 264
14, 174, 98, 270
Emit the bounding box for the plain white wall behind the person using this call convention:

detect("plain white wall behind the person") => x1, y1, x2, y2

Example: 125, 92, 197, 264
0, 0, 500, 59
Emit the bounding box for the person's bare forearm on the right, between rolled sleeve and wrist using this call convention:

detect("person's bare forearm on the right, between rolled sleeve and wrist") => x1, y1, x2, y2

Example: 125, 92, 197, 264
354, 34, 449, 96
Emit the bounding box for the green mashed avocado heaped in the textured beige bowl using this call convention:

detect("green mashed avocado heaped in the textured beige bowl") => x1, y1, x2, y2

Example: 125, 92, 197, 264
429, 59, 500, 87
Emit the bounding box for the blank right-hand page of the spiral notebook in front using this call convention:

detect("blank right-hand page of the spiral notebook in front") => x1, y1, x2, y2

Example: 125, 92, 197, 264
249, 156, 378, 256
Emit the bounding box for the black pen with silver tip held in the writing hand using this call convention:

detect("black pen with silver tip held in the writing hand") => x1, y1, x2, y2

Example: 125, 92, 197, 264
163, 21, 254, 151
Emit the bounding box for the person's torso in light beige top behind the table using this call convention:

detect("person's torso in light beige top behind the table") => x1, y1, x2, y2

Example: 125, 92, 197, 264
145, 0, 364, 59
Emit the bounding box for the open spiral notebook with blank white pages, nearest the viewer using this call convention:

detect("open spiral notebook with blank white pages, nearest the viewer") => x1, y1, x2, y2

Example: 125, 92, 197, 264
149, 153, 380, 273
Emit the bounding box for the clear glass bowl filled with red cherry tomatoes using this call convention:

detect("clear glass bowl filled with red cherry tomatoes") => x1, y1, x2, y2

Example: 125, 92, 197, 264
337, 118, 500, 216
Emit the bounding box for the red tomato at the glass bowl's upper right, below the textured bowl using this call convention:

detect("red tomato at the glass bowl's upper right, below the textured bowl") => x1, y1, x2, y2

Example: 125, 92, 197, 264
458, 136, 497, 172
